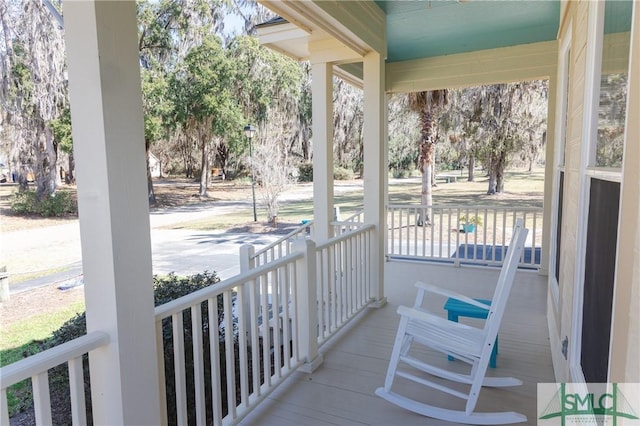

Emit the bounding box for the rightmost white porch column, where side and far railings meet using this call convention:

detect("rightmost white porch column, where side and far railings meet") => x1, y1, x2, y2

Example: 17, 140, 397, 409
364, 52, 389, 306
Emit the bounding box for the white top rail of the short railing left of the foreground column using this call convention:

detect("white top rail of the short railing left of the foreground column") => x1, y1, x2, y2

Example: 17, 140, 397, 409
0, 331, 109, 389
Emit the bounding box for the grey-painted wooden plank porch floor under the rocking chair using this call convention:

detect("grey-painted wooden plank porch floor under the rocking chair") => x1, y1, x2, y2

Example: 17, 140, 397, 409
241, 268, 554, 425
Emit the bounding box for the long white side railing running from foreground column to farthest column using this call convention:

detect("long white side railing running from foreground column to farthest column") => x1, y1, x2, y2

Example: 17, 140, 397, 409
156, 226, 375, 425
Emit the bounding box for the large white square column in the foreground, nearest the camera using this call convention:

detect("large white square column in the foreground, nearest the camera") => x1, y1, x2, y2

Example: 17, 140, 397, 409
64, 1, 160, 425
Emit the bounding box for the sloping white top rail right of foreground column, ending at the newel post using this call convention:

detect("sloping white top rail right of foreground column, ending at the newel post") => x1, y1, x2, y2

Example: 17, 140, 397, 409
155, 253, 303, 321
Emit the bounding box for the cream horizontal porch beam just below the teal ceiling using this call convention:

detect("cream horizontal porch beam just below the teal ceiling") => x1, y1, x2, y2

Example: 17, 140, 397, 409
386, 40, 558, 92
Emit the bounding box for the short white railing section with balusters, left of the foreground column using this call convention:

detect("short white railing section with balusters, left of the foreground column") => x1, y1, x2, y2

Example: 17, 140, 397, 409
0, 332, 109, 425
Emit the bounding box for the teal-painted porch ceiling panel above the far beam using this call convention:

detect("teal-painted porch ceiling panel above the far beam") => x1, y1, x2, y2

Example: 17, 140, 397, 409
376, 0, 560, 62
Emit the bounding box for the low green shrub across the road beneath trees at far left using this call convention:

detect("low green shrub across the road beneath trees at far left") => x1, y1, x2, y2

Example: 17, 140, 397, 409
11, 191, 78, 217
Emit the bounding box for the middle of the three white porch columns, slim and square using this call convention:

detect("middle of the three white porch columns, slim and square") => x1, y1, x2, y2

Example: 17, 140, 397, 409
311, 61, 333, 243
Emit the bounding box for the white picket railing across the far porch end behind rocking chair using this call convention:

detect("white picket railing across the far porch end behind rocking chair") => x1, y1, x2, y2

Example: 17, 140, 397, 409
387, 205, 543, 269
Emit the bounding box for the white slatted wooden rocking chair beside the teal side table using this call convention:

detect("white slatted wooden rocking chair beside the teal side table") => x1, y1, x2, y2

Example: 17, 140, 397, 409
376, 219, 528, 425
